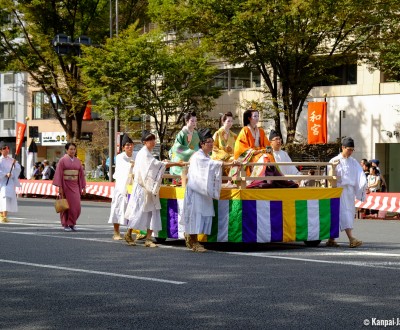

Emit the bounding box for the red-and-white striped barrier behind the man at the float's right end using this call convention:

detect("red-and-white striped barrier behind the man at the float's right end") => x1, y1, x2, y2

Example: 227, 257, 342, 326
355, 193, 400, 213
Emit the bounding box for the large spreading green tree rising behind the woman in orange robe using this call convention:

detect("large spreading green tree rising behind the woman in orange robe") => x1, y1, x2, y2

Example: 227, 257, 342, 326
149, 0, 391, 142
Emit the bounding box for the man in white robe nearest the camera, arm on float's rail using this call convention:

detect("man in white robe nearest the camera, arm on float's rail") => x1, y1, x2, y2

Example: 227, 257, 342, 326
181, 129, 241, 252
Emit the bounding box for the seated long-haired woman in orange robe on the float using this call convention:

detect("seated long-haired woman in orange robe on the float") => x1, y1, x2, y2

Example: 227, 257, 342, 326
230, 109, 274, 179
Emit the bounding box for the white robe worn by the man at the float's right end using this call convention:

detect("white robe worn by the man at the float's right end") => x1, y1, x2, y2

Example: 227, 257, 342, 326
329, 154, 367, 231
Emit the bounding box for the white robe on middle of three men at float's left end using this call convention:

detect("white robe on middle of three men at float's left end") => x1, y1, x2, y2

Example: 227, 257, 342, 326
125, 146, 166, 235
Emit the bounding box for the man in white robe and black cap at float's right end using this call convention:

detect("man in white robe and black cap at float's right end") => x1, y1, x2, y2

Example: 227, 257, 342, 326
326, 137, 367, 248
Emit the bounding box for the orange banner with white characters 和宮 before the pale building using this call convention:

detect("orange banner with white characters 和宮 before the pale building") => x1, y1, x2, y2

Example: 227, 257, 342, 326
307, 102, 328, 144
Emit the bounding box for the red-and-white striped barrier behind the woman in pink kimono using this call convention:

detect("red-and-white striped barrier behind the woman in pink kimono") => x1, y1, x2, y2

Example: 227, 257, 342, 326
16, 180, 114, 198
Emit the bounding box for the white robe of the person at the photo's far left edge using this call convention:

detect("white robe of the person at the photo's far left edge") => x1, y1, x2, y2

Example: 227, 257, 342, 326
0, 156, 21, 212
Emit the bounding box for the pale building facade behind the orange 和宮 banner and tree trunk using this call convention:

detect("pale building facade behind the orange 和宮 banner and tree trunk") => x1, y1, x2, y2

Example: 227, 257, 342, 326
211, 65, 400, 192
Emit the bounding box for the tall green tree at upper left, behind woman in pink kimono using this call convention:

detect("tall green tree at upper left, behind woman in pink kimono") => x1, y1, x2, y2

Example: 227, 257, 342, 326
0, 0, 146, 139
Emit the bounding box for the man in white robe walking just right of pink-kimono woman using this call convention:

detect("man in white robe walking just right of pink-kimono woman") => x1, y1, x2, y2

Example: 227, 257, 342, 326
108, 134, 135, 240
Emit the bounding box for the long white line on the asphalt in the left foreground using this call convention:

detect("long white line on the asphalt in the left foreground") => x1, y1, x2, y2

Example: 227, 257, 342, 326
0, 259, 187, 285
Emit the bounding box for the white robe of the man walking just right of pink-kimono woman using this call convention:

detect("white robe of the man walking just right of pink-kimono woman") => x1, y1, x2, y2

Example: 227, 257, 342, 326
108, 152, 133, 226
